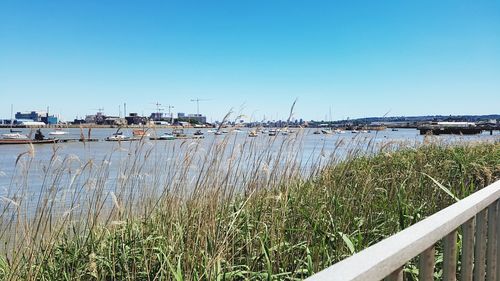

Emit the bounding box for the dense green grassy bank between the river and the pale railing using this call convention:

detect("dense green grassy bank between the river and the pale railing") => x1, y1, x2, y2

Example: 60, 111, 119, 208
0, 139, 500, 280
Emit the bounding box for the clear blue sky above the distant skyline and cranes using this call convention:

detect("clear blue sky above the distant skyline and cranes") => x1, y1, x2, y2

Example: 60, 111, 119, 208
0, 0, 500, 120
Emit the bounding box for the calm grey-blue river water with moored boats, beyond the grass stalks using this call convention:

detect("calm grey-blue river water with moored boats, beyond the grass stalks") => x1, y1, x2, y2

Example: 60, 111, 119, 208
0, 129, 500, 201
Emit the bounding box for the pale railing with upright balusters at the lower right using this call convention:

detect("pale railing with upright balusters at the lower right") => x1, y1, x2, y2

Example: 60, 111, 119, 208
307, 181, 500, 281
